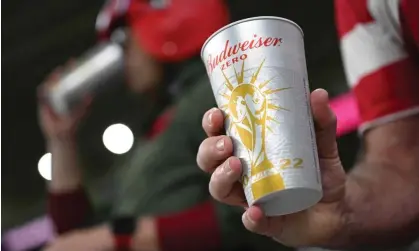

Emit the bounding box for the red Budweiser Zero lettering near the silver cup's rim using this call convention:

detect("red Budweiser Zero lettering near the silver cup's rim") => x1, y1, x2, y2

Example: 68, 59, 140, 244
208, 34, 282, 74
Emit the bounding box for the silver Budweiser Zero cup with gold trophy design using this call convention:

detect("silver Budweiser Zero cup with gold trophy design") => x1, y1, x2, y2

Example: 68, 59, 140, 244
201, 17, 322, 216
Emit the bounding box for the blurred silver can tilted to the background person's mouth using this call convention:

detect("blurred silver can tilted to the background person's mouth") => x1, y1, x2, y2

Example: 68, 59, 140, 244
47, 30, 125, 115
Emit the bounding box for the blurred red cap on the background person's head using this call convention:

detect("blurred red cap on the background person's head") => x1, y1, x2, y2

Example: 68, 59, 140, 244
128, 0, 229, 62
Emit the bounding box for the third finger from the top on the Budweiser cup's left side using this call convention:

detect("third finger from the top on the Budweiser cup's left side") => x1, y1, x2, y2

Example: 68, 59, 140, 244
209, 157, 247, 206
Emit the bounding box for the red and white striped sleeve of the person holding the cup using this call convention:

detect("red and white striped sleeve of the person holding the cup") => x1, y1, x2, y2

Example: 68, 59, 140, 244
335, 0, 419, 132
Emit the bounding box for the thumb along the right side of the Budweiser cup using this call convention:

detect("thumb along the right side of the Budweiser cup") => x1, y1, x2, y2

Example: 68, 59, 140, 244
311, 89, 346, 202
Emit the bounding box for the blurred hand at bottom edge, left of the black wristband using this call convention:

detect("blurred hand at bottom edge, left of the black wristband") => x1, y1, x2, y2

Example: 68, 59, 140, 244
44, 226, 113, 251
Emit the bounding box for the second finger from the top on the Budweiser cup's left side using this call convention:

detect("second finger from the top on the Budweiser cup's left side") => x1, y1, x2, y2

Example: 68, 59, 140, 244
196, 136, 233, 173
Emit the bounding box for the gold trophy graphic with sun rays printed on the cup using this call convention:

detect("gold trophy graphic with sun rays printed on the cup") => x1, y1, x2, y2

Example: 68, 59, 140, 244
220, 60, 290, 200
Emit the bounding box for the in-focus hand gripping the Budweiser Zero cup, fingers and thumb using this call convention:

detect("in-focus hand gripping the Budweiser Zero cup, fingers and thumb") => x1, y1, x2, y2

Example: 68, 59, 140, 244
197, 89, 346, 247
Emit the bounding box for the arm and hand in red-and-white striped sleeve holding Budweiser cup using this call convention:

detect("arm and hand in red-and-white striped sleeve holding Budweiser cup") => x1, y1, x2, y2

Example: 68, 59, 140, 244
198, 0, 419, 250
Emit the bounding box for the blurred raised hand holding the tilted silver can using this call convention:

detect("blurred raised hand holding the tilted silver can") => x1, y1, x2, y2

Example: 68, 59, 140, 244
38, 61, 91, 141
